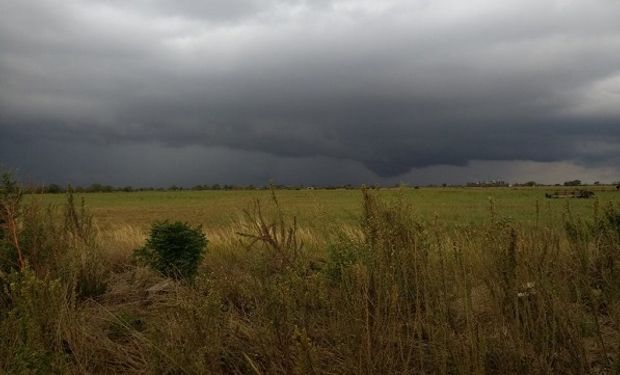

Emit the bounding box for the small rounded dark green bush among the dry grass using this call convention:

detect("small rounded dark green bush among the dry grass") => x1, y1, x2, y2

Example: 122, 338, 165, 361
134, 221, 207, 279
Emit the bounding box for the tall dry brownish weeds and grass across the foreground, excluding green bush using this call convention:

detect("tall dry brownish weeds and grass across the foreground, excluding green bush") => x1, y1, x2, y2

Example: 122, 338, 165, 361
0, 177, 620, 374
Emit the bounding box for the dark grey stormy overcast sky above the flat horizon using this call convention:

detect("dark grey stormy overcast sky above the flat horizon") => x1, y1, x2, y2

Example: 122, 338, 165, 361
0, 0, 620, 186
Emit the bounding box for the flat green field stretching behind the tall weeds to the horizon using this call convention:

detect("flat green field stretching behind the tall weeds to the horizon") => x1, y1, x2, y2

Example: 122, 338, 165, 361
31, 186, 620, 233
